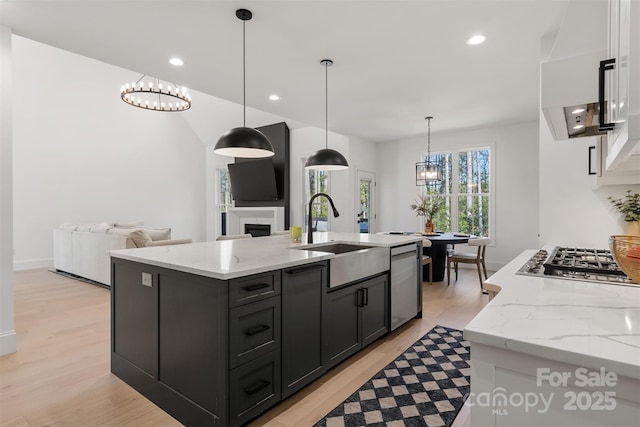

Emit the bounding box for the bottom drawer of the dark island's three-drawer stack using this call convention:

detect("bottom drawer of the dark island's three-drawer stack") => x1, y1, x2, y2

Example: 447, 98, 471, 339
229, 350, 280, 425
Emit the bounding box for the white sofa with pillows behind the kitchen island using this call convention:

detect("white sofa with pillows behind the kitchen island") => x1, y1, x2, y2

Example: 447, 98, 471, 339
53, 223, 191, 286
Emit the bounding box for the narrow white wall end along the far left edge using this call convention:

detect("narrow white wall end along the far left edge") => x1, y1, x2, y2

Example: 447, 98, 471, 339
0, 25, 17, 356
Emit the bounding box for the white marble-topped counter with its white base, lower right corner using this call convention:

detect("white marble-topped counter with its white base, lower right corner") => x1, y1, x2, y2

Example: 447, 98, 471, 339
464, 250, 640, 426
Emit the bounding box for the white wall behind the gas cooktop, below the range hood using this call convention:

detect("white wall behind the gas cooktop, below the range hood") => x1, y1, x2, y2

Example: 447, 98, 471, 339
540, 116, 640, 249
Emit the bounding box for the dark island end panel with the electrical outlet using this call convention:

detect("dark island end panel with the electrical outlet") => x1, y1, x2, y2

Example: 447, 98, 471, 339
111, 260, 158, 379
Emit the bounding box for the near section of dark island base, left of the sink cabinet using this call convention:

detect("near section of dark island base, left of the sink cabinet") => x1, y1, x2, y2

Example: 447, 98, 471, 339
111, 258, 327, 426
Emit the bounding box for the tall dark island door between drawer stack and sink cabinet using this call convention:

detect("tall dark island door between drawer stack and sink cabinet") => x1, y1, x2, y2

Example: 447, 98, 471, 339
282, 262, 327, 398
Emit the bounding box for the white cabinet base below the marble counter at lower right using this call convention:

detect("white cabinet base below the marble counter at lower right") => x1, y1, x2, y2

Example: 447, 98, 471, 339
466, 342, 640, 427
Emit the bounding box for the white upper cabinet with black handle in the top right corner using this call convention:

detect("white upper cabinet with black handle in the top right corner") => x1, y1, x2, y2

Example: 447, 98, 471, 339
604, 0, 640, 172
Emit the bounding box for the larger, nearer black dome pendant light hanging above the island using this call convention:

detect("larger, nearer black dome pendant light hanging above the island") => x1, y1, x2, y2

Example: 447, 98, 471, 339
213, 9, 274, 158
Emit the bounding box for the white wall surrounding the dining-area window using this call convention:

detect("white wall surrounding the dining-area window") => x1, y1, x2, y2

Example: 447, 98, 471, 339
378, 122, 538, 269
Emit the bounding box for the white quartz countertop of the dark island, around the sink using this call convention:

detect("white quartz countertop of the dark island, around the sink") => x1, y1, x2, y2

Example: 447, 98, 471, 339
111, 232, 423, 280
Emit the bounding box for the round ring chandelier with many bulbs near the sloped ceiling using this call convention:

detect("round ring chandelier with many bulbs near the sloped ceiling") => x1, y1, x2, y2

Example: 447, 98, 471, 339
120, 74, 191, 111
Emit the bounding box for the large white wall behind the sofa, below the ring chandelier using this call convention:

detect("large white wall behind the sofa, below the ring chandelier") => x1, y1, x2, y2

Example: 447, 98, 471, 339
13, 36, 205, 269
